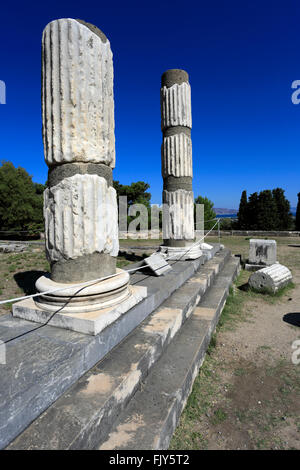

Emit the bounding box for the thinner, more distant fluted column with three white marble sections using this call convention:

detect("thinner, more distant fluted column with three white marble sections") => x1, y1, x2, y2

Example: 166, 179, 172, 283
160, 69, 201, 259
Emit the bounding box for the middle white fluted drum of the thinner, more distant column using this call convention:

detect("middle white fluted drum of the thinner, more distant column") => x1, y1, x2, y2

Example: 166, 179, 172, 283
161, 132, 193, 177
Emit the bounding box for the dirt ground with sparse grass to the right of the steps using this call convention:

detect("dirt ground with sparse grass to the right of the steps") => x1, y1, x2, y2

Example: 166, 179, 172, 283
170, 237, 300, 450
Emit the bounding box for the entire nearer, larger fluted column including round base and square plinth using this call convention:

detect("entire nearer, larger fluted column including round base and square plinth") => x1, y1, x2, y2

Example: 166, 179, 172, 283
13, 18, 147, 334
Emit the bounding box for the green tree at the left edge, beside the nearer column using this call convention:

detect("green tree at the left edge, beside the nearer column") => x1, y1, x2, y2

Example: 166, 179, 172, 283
0, 161, 44, 232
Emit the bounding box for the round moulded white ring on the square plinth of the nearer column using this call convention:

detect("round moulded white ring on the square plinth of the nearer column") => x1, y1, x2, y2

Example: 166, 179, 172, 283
35, 269, 130, 313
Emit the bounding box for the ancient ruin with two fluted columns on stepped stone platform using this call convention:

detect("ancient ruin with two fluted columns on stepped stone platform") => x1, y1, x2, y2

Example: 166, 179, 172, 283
0, 18, 240, 450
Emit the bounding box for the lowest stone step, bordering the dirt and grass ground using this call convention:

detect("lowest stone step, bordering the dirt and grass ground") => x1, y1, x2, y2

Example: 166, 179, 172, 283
98, 258, 239, 450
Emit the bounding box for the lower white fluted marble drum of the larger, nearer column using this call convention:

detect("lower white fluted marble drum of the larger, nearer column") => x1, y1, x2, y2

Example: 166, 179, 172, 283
44, 174, 119, 261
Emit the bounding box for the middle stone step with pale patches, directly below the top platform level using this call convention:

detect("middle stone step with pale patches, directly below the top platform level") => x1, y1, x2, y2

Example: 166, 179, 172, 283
8, 250, 230, 449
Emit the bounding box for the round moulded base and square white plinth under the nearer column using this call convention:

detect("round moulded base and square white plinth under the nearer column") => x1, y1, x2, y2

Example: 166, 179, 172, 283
12, 269, 147, 335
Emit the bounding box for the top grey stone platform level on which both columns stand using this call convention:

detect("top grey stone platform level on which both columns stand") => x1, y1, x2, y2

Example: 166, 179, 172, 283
0, 244, 219, 448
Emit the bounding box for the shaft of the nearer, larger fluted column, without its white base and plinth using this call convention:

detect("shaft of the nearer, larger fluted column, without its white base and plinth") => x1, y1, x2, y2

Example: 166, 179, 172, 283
42, 18, 119, 282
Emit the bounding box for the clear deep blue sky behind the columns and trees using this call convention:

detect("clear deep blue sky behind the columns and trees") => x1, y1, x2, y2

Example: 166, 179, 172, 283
0, 0, 300, 208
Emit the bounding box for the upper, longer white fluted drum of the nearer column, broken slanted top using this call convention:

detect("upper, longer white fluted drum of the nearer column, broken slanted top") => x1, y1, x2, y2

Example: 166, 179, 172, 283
42, 18, 115, 168
